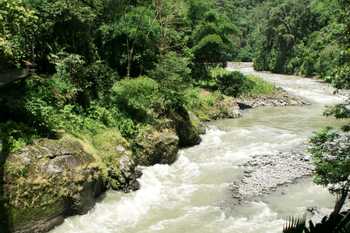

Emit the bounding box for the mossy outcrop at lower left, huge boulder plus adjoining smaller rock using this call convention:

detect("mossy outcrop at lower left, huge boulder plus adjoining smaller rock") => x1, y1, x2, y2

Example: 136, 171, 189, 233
3, 129, 141, 233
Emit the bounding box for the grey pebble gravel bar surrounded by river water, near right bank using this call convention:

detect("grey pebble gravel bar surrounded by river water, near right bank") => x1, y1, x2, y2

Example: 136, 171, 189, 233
232, 152, 313, 203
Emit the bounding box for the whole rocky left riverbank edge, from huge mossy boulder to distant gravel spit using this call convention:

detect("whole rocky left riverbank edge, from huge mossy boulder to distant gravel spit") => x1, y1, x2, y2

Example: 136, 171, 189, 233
0, 69, 304, 233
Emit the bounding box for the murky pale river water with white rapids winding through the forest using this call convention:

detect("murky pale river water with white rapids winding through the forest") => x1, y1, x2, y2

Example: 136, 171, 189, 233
51, 64, 344, 233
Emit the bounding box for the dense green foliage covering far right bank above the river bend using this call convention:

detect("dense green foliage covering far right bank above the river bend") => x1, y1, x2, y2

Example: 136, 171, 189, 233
247, 0, 350, 89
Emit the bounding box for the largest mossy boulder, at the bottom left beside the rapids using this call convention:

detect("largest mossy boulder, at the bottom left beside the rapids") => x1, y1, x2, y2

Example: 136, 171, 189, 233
3, 136, 103, 233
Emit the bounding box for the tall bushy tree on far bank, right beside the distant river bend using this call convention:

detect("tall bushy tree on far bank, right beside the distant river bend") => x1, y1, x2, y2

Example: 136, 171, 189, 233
254, 0, 319, 73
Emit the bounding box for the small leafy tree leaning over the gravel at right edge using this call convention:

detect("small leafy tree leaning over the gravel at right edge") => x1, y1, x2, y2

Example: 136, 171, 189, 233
309, 128, 350, 215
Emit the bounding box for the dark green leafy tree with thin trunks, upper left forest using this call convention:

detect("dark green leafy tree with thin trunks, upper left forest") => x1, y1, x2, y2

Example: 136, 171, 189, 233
100, 6, 160, 77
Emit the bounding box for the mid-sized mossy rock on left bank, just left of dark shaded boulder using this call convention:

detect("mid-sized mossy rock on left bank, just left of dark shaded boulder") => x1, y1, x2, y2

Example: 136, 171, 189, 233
133, 129, 179, 166
